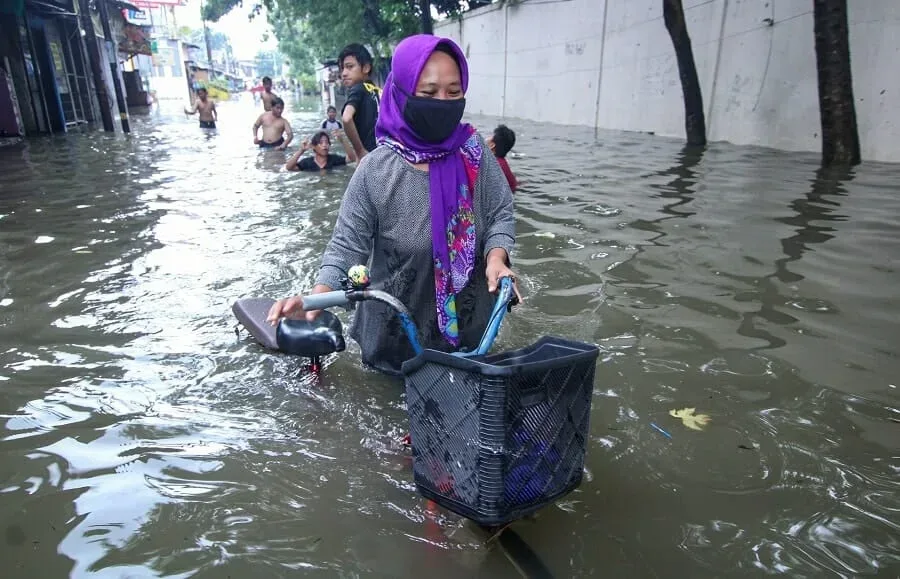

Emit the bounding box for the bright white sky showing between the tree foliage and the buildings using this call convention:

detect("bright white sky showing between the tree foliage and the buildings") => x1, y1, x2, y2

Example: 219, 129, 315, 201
175, 0, 278, 60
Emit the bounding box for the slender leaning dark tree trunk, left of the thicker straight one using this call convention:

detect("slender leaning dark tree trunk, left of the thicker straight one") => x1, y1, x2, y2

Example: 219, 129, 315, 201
663, 0, 706, 147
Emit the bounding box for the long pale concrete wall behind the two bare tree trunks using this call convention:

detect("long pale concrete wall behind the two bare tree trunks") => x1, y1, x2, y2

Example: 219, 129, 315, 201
435, 0, 900, 162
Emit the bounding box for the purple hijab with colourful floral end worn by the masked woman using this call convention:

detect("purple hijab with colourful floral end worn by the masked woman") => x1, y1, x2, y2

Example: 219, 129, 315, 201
375, 34, 481, 346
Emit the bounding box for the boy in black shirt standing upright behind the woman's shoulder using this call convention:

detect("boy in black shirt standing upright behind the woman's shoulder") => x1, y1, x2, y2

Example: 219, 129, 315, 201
338, 44, 381, 160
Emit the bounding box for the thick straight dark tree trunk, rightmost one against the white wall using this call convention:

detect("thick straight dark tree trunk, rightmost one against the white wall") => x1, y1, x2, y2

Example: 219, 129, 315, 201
813, 0, 860, 167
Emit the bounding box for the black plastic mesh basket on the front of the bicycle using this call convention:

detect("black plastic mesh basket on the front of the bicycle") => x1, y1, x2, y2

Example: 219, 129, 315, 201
403, 337, 599, 526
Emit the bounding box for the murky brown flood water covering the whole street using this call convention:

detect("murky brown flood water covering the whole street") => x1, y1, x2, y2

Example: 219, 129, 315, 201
0, 93, 900, 578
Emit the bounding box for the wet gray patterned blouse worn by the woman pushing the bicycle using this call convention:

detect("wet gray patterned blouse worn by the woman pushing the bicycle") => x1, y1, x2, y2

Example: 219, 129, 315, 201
316, 136, 515, 374
